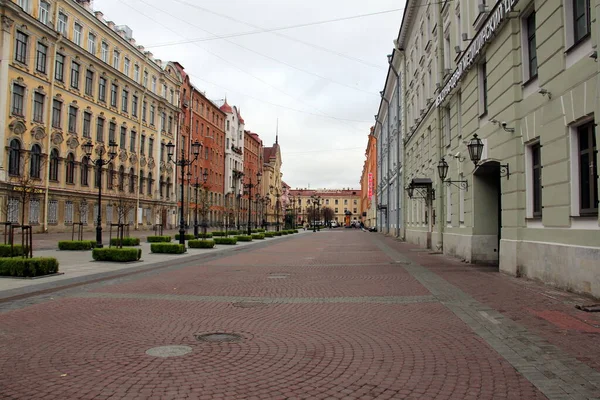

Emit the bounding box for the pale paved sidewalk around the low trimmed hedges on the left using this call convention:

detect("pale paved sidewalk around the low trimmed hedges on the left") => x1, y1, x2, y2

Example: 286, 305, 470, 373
0, 230, 305, 302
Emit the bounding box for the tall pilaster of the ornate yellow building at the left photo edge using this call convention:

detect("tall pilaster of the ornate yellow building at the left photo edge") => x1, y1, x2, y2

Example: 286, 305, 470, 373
0, 15, 15, 182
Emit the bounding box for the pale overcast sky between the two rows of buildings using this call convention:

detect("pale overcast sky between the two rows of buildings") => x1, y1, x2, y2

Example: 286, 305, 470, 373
94, 0, 404, 189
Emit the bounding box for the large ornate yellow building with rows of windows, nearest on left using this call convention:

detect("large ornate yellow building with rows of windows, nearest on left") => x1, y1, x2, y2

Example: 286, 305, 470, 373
0, 0, 181, 231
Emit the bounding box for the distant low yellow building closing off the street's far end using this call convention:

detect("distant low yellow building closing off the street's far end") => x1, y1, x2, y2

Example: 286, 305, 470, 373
289, 189, 362, 226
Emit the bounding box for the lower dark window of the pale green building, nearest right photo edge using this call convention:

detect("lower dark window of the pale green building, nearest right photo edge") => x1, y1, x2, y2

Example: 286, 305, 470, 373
577, 121, 598, 215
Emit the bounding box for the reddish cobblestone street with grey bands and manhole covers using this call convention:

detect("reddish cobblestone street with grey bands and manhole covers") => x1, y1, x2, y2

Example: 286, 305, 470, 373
0, 233, 600, 399
